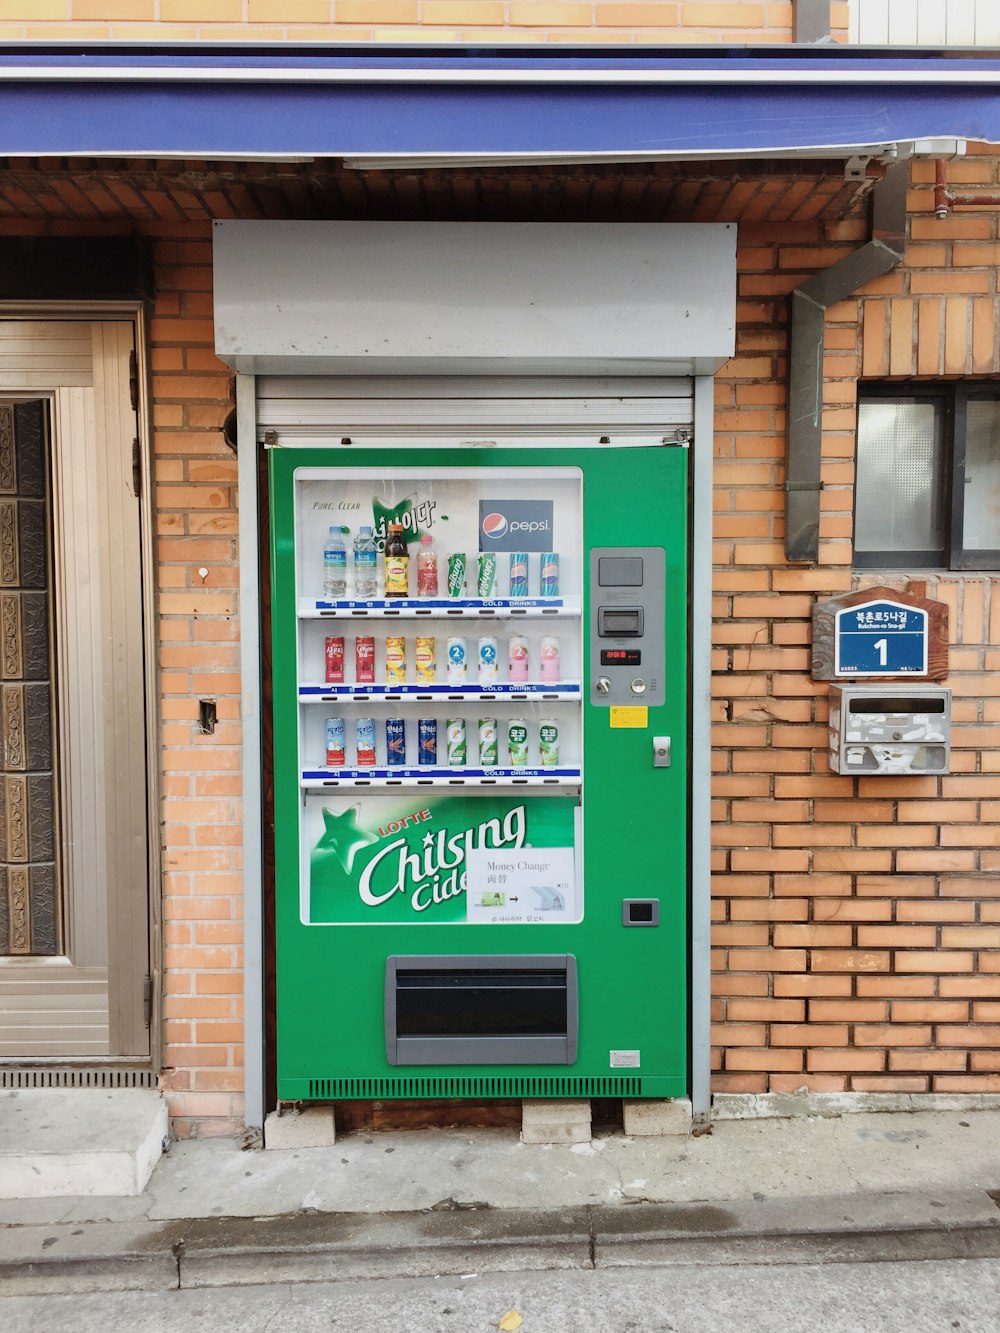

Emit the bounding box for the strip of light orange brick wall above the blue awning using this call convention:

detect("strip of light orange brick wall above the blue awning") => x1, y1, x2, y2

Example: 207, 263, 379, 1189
0, 0, 848, 43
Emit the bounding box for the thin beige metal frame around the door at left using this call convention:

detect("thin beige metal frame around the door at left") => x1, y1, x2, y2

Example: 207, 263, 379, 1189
0, 300, 163, 1088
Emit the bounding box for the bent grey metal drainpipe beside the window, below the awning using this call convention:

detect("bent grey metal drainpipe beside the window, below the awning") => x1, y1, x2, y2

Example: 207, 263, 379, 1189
785, 161, 909, 564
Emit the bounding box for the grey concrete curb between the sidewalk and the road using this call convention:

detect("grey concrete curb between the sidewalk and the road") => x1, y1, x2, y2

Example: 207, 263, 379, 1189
0, 1190, 1000, 1296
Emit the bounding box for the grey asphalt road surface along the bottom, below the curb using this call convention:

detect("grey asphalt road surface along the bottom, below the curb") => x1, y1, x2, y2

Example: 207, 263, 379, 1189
0, 1260, 1000, 1333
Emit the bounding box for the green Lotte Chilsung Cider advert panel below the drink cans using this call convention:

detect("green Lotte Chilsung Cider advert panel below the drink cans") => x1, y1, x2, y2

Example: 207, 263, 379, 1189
300, 789, 583, 925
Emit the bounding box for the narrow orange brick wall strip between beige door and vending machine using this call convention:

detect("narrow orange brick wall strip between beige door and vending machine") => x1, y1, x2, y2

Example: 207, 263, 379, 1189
145, 223, 249, 1136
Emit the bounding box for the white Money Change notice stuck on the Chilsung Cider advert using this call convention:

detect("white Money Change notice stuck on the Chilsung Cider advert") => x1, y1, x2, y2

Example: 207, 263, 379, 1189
465, 846, 580, 925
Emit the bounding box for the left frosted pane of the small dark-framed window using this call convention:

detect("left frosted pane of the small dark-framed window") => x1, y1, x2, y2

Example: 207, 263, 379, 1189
855, 400, 945, 552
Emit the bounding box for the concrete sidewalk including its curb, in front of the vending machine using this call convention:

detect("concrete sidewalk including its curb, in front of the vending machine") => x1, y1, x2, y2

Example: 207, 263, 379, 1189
0, 1108, 1000, 1294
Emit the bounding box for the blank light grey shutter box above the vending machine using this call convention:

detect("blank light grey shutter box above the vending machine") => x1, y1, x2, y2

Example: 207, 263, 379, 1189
213, 221, 736, 376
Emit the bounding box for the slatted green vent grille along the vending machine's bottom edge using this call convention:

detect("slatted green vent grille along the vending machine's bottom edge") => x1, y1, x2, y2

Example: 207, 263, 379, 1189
309, 1076, 643, 1101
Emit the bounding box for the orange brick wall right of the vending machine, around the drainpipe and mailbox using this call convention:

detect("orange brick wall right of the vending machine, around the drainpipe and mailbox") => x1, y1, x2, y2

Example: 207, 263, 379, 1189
713, 157, 1000, 1093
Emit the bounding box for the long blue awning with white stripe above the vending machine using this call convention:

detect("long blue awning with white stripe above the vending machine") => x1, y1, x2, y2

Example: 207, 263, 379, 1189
0, 44, 1000, 160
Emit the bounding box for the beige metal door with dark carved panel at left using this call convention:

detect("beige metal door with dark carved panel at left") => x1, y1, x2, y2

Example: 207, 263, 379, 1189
0, 321, 149, 1064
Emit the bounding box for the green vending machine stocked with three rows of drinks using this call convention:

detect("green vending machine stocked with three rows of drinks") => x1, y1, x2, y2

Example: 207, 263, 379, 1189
269, 437, 688, 1101
